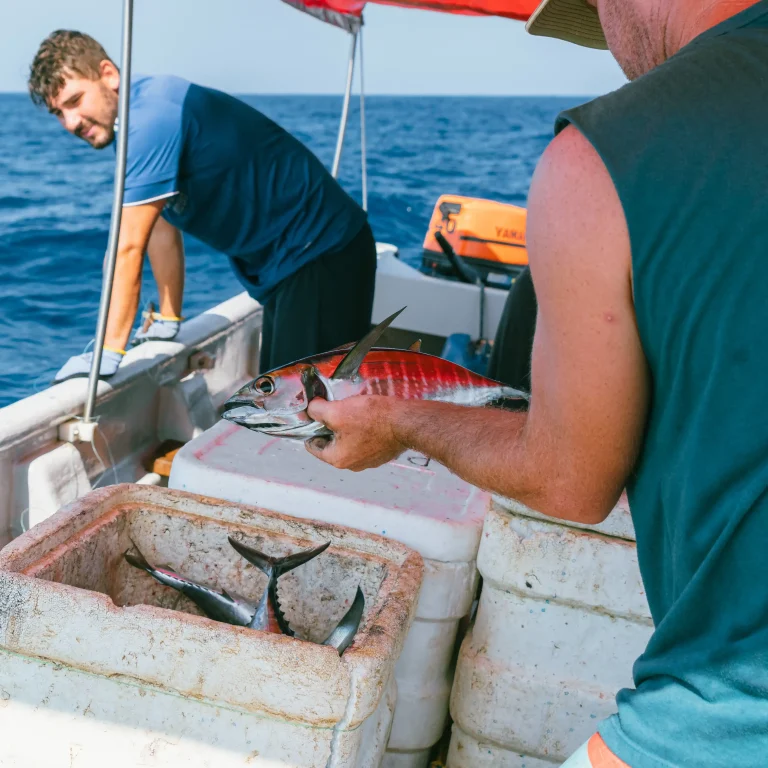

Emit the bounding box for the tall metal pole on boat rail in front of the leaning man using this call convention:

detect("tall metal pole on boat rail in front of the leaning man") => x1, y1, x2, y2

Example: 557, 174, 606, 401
83, 0, 133, 423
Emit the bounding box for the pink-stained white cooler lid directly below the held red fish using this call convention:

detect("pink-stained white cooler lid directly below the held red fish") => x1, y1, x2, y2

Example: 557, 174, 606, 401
169, 421, 490, 562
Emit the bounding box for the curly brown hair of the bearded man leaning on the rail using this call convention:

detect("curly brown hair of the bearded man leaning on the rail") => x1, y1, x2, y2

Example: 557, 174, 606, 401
27, 29, 114, 106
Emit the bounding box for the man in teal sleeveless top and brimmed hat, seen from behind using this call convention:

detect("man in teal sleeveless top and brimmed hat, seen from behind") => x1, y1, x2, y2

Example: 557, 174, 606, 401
309, 0, 768, 768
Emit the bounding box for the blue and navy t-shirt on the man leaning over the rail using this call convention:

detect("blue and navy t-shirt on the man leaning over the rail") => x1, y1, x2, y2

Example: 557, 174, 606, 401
124, 76, 366, 300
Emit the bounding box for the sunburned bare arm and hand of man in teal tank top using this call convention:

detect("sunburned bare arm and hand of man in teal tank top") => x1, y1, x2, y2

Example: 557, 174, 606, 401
308, 128, 647, 523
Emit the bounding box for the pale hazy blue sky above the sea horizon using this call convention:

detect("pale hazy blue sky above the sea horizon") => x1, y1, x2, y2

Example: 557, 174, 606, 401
0, 0, 624, 95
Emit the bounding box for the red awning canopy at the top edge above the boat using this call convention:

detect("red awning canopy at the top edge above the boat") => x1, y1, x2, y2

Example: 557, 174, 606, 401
284, 0, 538, 31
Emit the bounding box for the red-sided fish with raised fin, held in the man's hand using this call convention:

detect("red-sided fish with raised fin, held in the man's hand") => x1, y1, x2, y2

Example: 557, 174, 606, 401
222, 307, 528, 440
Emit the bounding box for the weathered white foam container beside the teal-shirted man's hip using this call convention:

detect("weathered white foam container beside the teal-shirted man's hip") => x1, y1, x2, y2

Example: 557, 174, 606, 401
448, 497, 652, 768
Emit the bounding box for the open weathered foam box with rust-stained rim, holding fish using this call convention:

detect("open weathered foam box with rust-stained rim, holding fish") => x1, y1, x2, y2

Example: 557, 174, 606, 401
0, 485, 422, 768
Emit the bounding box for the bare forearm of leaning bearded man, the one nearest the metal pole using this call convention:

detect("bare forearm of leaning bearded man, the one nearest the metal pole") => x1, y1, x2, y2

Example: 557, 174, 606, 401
104, 200, 166, 349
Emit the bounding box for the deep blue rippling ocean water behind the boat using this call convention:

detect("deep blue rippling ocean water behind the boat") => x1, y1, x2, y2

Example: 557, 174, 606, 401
0, 94, 585, 407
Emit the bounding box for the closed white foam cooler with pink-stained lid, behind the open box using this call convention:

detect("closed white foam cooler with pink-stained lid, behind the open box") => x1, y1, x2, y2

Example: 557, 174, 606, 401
169, 421, 490, 768
